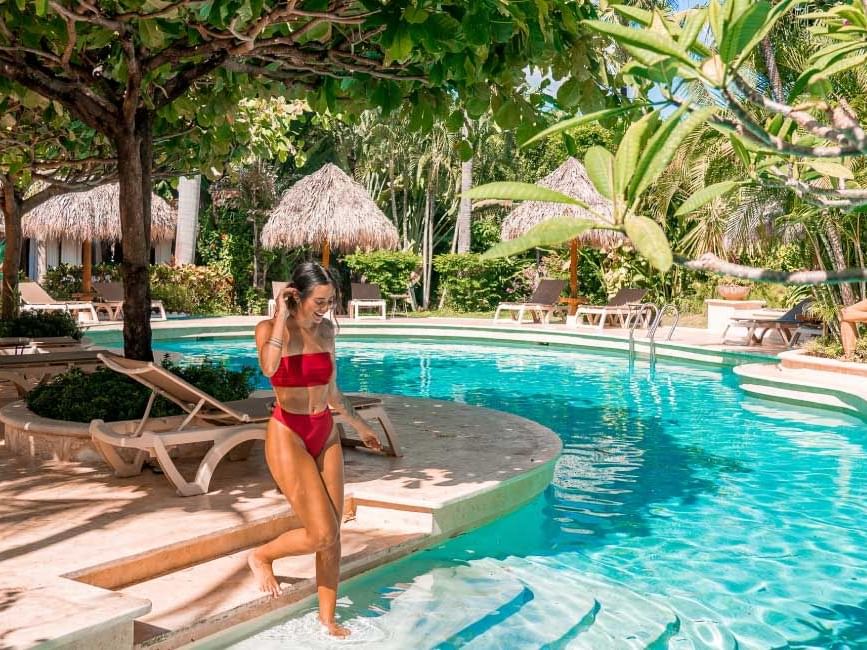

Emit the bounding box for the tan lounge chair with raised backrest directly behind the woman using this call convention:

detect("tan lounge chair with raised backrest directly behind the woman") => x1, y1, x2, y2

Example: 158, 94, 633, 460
90, 353, 400, 496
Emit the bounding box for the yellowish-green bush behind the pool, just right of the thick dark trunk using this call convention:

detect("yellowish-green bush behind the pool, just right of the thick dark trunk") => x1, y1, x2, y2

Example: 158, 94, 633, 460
151, 264, 238, 315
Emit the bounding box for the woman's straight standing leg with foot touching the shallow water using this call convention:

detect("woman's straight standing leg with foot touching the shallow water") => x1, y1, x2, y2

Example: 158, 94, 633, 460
316, 428, 349, 636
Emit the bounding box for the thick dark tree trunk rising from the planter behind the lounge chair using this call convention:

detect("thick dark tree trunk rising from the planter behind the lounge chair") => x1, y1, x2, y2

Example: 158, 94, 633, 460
114, 114, 153, 361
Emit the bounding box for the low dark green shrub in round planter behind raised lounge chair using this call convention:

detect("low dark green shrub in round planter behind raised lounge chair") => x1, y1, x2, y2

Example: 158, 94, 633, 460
27, 359, 255, 422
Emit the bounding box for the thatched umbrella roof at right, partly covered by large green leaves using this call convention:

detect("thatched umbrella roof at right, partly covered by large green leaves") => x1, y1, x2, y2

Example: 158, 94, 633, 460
500, 158, 623, 248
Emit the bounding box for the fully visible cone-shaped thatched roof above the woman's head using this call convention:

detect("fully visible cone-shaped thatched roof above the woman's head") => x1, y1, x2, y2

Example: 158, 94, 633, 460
262, 163, 399, 252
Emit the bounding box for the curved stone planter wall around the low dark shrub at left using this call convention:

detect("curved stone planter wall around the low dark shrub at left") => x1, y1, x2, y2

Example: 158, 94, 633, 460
0, 401, 210, 465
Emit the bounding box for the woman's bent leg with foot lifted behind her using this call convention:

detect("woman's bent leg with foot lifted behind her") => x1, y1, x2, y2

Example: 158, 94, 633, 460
248, 420, 342, 596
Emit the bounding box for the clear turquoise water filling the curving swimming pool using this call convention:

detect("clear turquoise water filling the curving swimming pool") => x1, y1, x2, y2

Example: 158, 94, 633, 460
159, 340, 867, 649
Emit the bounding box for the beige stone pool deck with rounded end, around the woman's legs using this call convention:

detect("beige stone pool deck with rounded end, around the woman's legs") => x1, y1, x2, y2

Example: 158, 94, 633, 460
0, 396, 560, 650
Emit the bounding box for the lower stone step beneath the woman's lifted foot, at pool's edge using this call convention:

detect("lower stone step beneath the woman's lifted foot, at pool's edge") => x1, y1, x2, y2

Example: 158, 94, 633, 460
120, 522, 425, 648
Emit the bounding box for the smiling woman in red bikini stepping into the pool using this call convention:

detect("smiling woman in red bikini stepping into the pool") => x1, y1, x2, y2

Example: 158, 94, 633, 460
248, 262, 381, 636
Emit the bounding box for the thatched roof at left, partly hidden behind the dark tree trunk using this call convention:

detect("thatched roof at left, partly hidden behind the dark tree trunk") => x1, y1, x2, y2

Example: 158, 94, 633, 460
21, 183, 178, 241
